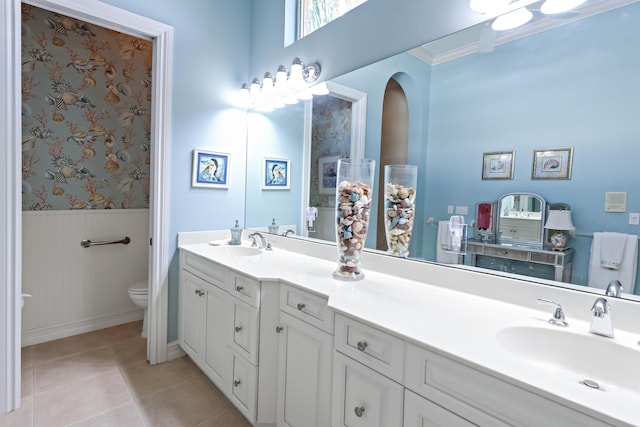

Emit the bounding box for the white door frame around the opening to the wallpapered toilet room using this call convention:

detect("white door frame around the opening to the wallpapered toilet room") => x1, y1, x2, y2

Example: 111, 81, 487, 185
0, 0, 173, 414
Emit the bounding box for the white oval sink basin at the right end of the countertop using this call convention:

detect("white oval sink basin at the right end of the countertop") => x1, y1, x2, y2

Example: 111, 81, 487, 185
497, 326, 640, 393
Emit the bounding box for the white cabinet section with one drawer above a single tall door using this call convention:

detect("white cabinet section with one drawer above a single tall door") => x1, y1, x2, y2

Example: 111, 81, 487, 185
277, 285, 333, 427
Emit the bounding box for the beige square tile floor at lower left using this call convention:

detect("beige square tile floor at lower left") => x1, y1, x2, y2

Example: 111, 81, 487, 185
0, 322, 250, 427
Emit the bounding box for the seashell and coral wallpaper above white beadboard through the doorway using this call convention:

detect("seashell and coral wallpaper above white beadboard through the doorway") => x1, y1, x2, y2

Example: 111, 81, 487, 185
22, 3, 153, 211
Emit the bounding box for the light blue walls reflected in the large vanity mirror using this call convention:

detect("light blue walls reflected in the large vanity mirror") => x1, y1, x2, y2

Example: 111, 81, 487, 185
245, 0, 640, 300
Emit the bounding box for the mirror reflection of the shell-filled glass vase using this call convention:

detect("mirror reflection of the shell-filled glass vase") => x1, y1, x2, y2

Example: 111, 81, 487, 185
384, 165, 418, 258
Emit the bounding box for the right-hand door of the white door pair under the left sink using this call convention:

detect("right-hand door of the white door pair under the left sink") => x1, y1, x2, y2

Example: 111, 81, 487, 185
202, 286, 231, 394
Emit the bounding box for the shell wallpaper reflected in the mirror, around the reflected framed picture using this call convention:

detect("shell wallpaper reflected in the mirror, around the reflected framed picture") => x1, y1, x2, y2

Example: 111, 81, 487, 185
309, 95, 352, 207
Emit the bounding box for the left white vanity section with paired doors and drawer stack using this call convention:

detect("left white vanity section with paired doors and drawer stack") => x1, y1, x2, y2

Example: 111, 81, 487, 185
178, 251, 279, 426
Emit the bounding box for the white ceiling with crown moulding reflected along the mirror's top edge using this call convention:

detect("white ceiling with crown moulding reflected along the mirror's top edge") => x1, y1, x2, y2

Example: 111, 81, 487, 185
409, 0, 640, 65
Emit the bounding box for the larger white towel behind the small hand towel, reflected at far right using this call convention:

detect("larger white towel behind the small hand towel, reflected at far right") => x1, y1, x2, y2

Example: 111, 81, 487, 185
588, 232, 638, 293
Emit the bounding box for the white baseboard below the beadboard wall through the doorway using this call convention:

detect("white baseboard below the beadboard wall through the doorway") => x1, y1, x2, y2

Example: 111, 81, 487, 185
22, 310, 144, 347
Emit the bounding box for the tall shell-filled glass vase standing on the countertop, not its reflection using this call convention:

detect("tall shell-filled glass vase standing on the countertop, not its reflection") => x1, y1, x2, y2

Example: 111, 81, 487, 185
333, 159, 376, 280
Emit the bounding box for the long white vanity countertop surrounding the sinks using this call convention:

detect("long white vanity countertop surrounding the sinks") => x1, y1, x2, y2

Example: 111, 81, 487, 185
179, 237, 640, 426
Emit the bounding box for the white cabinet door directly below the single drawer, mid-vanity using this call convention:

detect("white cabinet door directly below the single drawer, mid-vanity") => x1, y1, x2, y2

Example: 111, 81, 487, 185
278, 312, 333, 427
